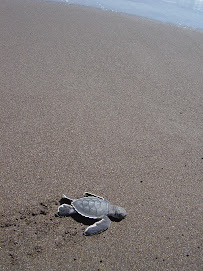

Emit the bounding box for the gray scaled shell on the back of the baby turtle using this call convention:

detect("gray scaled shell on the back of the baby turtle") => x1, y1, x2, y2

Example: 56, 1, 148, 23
72, 197, 109, 219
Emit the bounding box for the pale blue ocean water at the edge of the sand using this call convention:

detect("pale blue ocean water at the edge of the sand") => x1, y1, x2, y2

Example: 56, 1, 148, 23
46, 0, 203, 30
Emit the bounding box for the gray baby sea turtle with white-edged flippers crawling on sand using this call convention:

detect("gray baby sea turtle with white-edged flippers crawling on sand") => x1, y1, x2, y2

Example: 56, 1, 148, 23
58, 192, 127, 235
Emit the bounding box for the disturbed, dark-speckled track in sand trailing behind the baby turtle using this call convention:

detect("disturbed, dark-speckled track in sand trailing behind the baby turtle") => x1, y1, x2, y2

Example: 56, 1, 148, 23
0, 200, 85, 270
